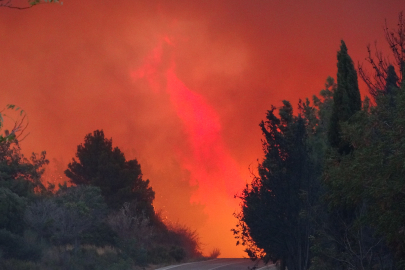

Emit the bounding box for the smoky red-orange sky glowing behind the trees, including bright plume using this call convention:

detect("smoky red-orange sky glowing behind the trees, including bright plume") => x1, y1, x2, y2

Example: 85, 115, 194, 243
0, 0, 405, 257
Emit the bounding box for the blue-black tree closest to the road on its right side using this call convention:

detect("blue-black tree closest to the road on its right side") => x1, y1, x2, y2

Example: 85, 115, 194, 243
233, 101, 316, 270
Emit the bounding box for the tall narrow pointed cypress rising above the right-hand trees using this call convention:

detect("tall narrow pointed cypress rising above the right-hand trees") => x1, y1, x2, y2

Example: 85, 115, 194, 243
328, 40, 361, 153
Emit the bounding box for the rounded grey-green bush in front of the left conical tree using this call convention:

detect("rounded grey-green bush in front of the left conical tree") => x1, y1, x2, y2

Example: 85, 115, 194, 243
25, 186, 107, 245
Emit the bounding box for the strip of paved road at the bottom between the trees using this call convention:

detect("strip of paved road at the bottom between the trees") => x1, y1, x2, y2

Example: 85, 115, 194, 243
156, 259, 276, 270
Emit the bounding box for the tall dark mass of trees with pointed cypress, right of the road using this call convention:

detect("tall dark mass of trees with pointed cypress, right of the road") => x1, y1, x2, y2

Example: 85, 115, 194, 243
233, 13, 405, 270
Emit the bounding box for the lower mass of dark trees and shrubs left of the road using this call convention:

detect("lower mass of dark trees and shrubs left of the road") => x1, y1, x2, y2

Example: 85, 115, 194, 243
0, 130, 202, 270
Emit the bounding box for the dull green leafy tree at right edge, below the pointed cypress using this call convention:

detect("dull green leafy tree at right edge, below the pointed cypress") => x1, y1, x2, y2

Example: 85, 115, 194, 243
324, 79, 405, 269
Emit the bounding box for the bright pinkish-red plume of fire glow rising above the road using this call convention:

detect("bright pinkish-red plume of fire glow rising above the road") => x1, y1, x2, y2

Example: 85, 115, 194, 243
132, 36, 244, 257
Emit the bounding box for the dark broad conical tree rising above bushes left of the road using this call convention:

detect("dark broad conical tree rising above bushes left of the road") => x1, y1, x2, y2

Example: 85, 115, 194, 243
65, 130, 155, 217
